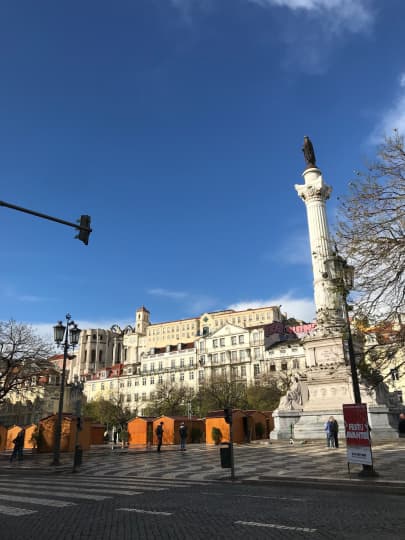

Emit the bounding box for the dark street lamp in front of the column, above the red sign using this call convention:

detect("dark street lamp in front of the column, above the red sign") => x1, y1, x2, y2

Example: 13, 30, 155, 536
325, 254, 361, 404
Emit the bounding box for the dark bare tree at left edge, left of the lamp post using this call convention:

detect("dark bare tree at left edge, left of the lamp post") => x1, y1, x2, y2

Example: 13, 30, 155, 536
0, 320, 54, 403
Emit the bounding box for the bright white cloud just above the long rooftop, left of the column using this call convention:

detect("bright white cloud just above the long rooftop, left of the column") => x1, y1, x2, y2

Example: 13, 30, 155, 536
228, 293, 315, 322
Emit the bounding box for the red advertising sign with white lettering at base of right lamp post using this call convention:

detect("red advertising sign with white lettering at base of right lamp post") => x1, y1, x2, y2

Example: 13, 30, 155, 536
343, 403, 373, 465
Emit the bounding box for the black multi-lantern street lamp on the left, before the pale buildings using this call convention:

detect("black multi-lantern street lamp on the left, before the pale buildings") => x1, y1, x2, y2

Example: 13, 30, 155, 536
52, 313, 80, 465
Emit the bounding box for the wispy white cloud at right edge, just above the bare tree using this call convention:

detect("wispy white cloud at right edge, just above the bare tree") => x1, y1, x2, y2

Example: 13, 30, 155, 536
369, 73, 405, 144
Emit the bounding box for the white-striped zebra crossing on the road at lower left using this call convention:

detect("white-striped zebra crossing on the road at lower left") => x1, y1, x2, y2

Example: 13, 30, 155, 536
0, 475, 211, 517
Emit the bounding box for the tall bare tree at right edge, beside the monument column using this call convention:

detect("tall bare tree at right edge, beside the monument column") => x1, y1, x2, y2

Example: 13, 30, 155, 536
337, 130, 405, 345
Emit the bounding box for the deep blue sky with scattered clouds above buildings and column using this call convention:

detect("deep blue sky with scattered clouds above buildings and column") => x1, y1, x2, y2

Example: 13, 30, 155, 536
0, 0, 405, 338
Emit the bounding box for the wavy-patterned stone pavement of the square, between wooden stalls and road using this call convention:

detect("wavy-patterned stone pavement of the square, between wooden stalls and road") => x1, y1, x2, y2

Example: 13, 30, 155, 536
0, 440, 405, 488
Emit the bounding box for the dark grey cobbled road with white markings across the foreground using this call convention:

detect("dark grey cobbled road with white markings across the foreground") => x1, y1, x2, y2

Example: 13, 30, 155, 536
0, 473, 405, 540
